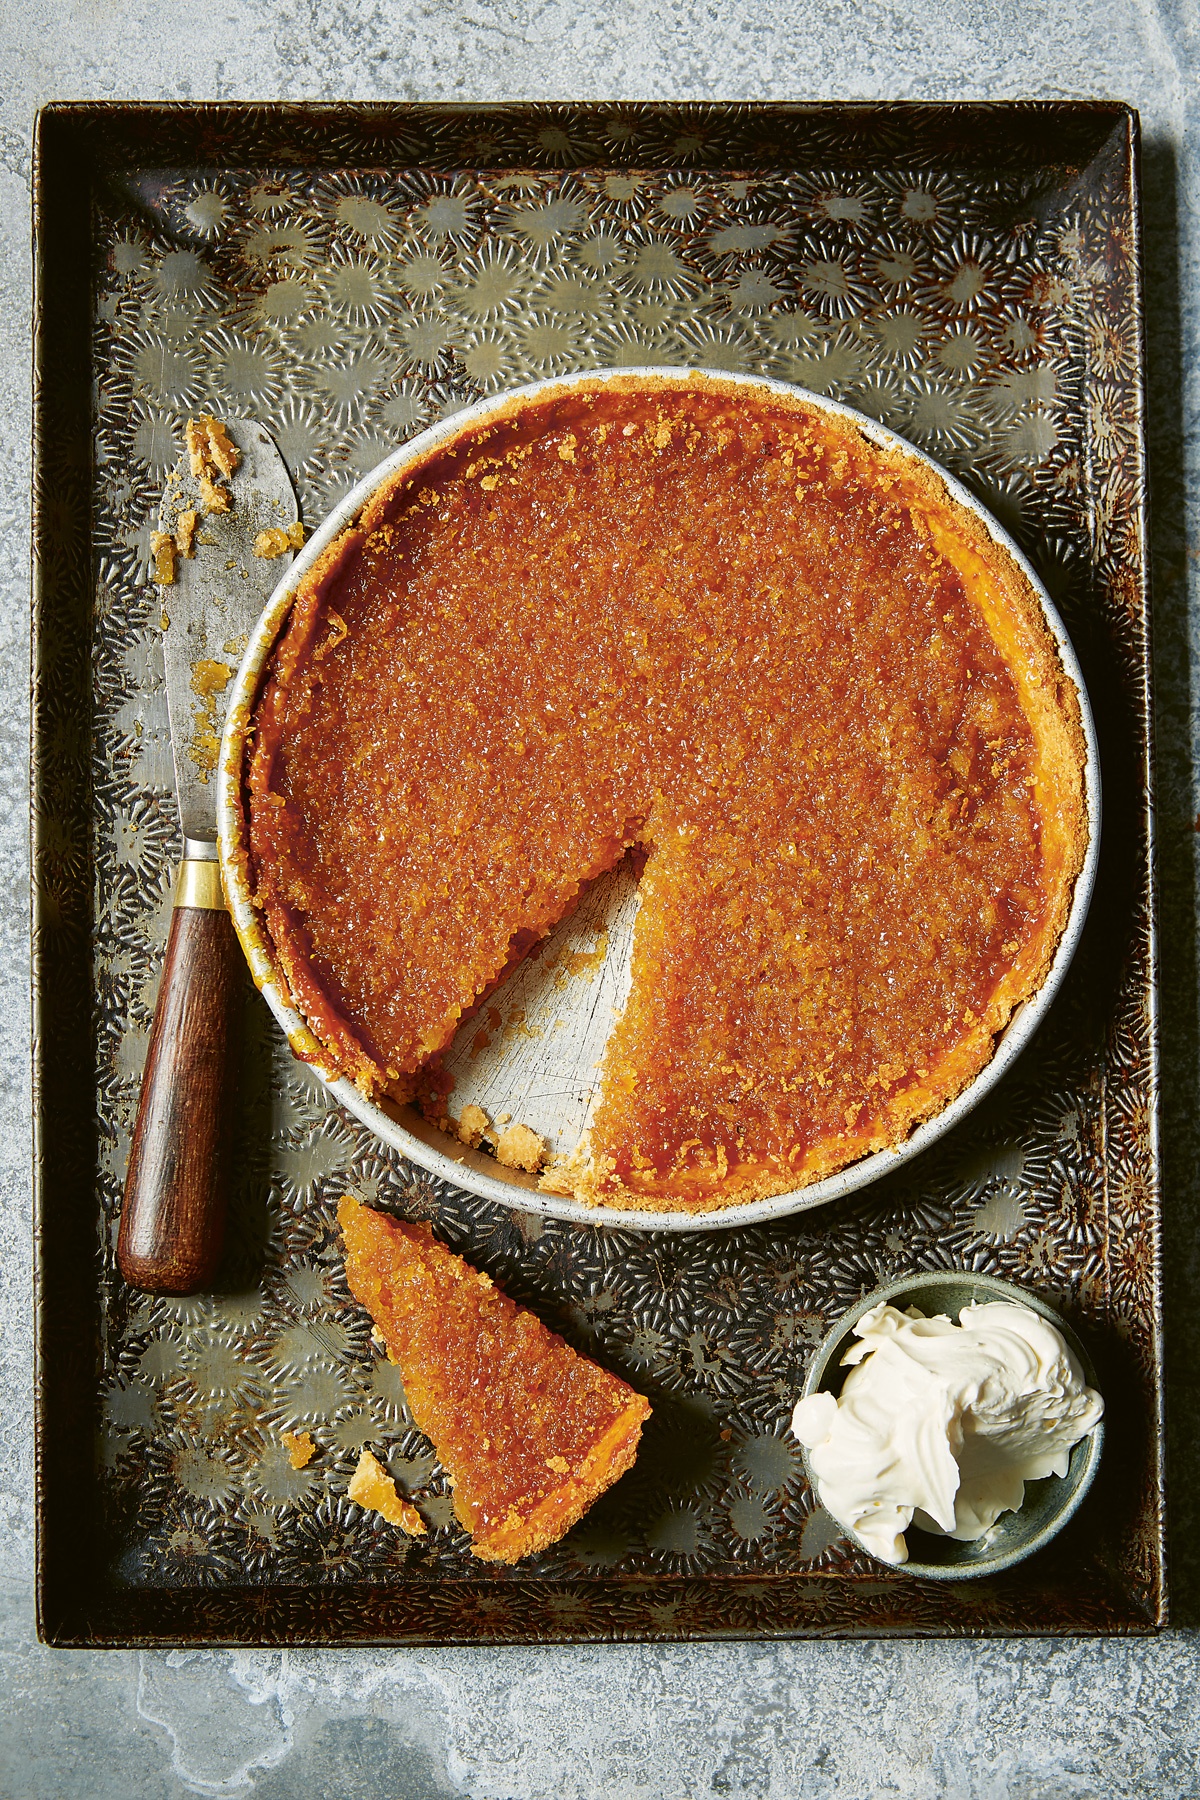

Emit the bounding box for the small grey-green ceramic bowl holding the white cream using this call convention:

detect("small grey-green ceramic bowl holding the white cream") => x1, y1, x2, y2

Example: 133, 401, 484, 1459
801, 1269, 1105, 1580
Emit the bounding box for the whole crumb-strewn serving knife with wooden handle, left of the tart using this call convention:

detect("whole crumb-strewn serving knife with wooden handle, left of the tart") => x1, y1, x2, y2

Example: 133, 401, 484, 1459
117, 418, 300, 1294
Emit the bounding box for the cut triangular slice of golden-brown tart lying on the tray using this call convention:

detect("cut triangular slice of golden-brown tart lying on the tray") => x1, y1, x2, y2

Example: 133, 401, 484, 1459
338, 1193, 649, 1562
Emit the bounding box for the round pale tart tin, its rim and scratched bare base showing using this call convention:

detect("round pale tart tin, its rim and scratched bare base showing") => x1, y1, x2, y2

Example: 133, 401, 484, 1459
219, 369, 1099, 1229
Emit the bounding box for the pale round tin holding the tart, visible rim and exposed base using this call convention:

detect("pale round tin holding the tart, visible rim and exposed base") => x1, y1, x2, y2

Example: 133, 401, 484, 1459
218, 367, 1101, 1231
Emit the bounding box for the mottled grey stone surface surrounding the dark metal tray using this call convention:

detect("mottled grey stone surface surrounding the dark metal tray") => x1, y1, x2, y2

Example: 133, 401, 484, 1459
0, 0, 1200, 1800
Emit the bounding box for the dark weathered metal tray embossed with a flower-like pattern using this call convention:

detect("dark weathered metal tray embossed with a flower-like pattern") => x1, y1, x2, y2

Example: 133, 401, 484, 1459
34, 103, 1166, 1643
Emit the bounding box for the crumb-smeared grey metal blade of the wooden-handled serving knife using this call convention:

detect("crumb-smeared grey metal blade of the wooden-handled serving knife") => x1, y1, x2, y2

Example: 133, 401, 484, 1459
158, 416, 299, 855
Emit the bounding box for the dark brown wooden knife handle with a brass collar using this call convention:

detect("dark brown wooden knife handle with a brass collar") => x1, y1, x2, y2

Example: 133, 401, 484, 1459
117, 862, 245, 1294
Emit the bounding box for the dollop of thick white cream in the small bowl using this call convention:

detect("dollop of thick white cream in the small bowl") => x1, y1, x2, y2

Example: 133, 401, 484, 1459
792, 1300, 1105, 1562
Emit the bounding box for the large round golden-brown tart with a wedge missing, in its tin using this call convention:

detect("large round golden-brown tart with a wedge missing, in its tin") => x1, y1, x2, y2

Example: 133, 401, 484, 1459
246, 376, 1088, 1210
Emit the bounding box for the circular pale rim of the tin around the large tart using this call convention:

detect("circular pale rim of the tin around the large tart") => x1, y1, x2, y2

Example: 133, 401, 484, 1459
218, 365, 1101, 1231
